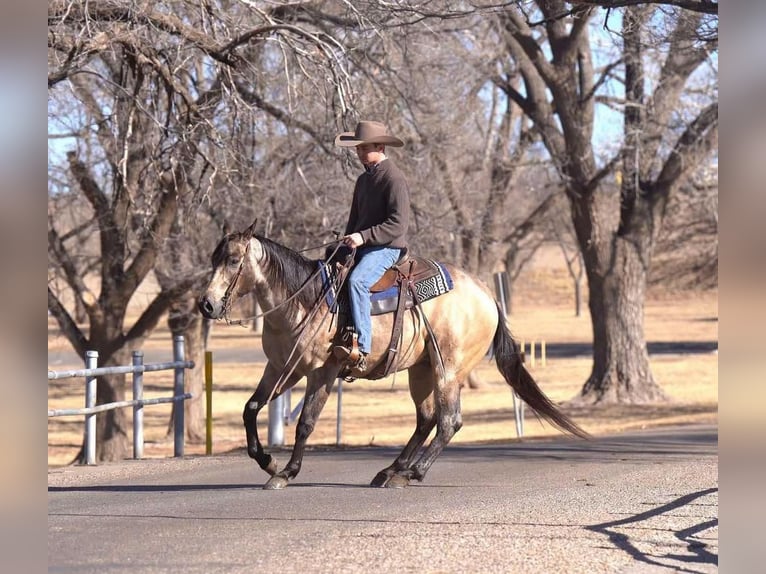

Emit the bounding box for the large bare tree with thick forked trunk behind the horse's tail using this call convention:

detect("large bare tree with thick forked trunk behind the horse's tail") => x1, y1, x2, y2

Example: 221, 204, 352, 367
498, 0, 718, 402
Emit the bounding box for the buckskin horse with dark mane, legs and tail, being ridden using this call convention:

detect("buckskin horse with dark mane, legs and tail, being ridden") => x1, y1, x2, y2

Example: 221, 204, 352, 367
198, 223, 589, 490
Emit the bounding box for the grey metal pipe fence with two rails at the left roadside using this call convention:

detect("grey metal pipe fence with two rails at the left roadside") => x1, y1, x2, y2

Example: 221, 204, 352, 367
48, 335, 194, 464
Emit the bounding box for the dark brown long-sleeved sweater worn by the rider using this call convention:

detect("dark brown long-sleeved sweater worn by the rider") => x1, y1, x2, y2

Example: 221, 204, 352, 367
345, 159, 410, 248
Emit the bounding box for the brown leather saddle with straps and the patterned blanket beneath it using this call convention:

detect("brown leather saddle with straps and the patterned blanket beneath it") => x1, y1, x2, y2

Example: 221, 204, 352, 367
328, 252, 453, 379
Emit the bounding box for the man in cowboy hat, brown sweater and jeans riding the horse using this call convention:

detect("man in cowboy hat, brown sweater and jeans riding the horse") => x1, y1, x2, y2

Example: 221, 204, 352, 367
334, 121, 410, 374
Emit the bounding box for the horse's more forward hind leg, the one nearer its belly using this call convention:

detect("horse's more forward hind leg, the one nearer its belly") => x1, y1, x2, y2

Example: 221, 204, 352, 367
370, 364, 436, 488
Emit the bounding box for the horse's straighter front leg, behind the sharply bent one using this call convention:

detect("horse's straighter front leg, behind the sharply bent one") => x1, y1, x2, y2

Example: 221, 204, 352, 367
263, 365, 339, 490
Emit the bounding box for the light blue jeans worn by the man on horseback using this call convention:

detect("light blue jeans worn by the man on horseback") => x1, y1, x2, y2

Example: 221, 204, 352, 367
348, 246, 402, 353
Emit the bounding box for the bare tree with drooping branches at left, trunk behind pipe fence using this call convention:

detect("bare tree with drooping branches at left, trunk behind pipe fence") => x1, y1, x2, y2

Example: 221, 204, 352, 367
48, 0, 356, 460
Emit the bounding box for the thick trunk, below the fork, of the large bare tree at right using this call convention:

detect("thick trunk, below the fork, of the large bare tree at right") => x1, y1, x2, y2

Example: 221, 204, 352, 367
574, 236, 668, 404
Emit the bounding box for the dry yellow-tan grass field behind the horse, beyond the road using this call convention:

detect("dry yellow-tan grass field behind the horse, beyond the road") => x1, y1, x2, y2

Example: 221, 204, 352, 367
48, 290, 718, 465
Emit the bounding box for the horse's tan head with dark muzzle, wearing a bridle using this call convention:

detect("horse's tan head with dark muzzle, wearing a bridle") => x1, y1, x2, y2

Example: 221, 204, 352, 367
197, 222, 263, 319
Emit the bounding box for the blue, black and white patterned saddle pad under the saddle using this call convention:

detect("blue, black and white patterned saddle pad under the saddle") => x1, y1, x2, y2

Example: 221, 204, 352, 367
319, 261, 454, 315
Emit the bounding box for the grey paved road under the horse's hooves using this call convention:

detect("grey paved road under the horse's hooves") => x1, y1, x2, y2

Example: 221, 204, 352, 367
48, 426, 718, 574
